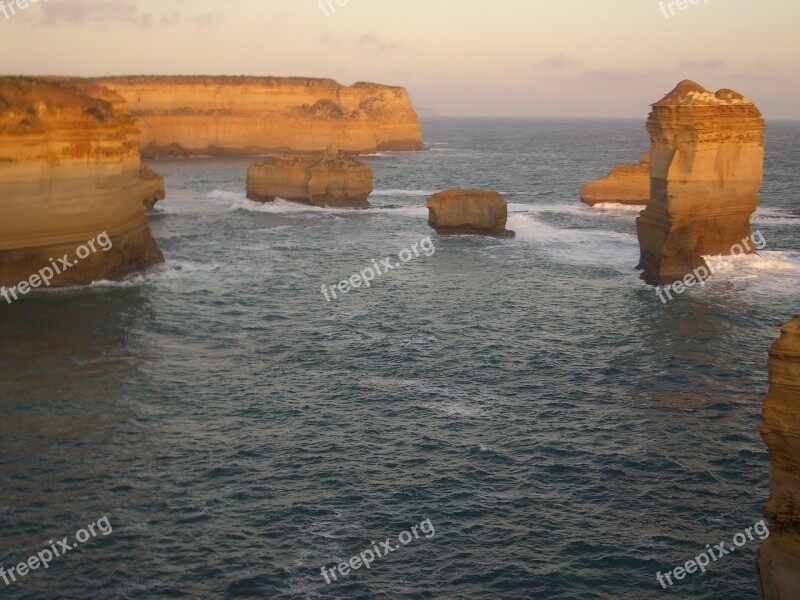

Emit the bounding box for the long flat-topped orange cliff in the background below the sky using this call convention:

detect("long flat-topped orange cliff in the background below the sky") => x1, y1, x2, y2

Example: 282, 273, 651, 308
98, 77, 422, 155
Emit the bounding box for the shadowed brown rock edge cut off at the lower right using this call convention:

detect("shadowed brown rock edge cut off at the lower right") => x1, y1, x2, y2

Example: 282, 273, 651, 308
756, 316, 800, 600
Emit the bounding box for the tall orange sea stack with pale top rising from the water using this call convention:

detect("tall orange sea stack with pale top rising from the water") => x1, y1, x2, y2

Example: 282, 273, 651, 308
637, 81, 765, 285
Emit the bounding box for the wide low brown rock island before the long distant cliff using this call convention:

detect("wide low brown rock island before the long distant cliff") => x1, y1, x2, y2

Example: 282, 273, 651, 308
247, 147, 372, 208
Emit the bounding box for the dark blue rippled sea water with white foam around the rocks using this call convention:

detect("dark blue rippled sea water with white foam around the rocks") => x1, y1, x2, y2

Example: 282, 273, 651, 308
0, 119, 800, 599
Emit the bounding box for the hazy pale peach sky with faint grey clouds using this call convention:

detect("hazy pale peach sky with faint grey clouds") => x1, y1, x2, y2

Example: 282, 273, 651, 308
0, 0, 800, 119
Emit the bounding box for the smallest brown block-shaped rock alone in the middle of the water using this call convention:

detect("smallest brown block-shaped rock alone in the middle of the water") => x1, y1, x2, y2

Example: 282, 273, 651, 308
428, 190, 514, 237
